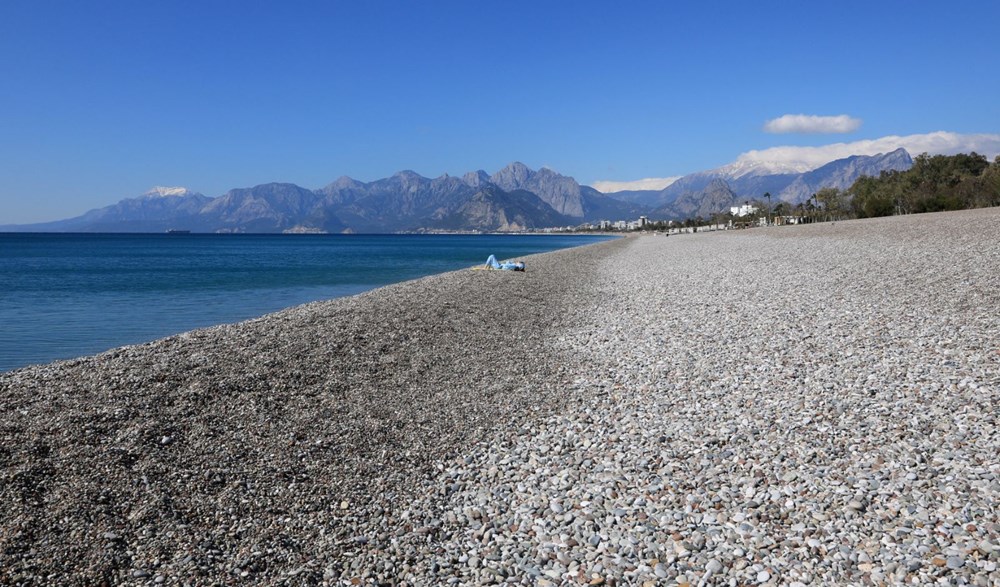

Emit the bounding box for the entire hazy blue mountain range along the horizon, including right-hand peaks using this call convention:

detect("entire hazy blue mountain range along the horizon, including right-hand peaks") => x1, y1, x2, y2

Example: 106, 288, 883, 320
0, 149, 912, 233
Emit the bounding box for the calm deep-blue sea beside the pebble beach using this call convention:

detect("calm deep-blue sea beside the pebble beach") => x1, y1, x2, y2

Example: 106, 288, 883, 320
0, 233, 609, 371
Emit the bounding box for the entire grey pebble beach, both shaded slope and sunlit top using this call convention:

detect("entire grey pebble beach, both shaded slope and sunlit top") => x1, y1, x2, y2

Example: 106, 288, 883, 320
0, 208, 1000, 585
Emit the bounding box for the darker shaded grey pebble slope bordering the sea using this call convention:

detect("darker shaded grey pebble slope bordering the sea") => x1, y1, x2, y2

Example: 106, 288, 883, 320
0, 242, 624, 583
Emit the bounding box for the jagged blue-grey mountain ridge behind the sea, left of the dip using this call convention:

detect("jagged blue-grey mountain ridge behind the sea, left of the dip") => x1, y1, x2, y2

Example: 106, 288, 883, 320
2, 162, 644, 233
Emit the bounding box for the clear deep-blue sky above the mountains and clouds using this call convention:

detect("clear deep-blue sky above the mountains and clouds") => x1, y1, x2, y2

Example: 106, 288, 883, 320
0, 0, 1000, 224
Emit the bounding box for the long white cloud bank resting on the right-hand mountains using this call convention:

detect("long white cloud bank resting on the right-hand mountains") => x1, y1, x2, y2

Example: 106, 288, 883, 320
736, 131, 1000, 169
